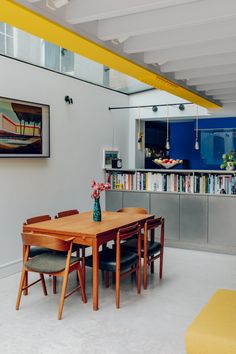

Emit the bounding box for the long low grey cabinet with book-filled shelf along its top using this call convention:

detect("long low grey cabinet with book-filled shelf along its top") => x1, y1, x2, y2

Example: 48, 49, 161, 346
106, 169, 236, 255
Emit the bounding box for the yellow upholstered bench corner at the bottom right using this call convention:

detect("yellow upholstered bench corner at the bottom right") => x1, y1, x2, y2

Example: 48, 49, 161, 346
185, 289, 236, 354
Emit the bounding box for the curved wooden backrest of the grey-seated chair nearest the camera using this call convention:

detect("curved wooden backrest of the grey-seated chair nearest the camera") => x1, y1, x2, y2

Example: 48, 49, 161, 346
21, 232, 74, 252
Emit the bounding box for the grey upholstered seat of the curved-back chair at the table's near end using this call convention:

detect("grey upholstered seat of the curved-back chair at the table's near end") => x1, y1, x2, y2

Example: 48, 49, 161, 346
25, 253, 80, 274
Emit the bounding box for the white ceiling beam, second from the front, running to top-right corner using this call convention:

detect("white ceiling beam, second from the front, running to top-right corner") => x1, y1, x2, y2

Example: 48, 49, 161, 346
97, 0, 236, 41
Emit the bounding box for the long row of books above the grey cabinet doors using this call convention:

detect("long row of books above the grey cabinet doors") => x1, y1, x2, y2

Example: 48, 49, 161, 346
106, 172, 236, 194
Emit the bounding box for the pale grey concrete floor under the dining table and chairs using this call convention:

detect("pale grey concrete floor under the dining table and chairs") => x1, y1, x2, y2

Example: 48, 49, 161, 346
0, 248, 236, 354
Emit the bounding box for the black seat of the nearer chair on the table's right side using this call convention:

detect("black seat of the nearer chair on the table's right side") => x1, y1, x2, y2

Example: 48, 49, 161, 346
85, 248, 138, 272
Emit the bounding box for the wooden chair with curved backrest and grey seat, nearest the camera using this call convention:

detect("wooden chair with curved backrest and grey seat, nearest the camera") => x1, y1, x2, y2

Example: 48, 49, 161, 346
16, 233, 87, 320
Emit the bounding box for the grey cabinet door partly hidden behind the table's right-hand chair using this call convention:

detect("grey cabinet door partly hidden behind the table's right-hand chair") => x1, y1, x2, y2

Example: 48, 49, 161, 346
150, 193, 179, 240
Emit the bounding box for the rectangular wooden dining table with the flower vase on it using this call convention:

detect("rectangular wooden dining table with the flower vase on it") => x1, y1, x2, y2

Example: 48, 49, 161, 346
23, 211, 154, 311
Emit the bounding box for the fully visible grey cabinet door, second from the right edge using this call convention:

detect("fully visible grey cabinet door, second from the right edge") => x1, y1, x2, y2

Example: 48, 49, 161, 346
180, 195, 207, 243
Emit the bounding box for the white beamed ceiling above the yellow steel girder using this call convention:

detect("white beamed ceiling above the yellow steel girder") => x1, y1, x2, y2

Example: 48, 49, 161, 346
18, 0, 236, 103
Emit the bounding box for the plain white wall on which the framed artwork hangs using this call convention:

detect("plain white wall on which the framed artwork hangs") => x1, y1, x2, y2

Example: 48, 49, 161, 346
0, 57, 128, 276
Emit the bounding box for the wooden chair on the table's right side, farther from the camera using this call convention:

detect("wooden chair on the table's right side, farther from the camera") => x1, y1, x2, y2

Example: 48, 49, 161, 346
122, 217, 165, 289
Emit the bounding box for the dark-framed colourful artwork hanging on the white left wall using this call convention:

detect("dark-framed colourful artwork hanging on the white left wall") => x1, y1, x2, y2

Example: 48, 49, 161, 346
0, 97, 50, 157
